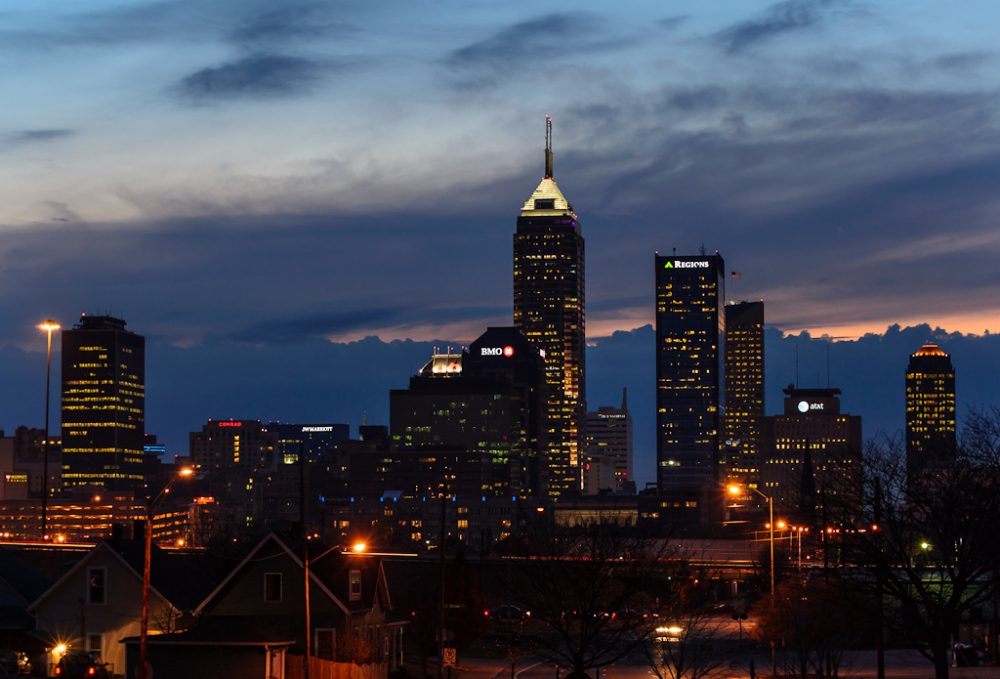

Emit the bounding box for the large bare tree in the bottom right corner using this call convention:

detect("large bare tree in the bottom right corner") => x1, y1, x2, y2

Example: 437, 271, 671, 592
850, 438, 1000, 679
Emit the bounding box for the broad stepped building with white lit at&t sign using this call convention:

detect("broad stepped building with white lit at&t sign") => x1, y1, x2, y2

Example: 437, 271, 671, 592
760, 384, 861, 525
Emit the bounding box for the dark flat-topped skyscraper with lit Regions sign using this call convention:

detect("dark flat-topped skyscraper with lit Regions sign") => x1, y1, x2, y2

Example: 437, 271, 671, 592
655, 253, 725, 524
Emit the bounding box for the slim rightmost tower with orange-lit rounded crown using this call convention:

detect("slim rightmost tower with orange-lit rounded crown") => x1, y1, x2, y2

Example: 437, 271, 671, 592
906, 343, 956, 481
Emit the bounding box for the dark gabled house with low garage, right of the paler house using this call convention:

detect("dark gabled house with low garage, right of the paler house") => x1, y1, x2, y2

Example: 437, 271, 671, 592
125, 533, 402, 679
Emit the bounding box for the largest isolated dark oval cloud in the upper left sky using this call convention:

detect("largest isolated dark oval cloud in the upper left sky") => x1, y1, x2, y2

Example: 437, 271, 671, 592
175, 53, 326, 102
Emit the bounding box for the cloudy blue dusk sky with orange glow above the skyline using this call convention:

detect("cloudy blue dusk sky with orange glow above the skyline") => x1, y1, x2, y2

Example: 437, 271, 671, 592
0, 0, 1000, 486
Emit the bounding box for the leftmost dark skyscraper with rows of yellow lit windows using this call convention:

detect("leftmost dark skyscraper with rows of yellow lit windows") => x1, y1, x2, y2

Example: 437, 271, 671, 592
62, 314, 146, 490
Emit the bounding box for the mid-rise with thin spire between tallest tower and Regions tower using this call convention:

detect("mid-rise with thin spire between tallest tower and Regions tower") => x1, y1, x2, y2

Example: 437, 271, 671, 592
584, 389, 635, 495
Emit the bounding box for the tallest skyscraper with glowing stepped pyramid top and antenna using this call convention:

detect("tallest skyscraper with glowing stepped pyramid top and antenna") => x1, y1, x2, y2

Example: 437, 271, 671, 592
514, 118, 586, 497
